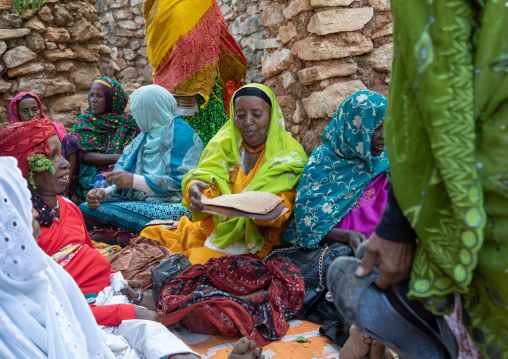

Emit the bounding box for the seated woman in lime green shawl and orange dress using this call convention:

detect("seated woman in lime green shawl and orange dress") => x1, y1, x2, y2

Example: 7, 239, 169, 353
140, 84, 307, 264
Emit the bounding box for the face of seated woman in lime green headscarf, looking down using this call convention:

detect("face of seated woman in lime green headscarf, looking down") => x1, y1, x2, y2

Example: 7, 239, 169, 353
234, 96, 272, 148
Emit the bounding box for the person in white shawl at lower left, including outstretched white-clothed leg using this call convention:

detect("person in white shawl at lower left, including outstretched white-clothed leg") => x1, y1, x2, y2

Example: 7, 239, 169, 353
0, 157, 208, 359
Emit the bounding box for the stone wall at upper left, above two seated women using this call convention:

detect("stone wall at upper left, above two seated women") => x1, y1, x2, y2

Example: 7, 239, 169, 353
0, 0, 119, 129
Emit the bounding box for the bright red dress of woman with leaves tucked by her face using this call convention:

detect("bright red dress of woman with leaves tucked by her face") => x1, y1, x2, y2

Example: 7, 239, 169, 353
38, 196, 136, 326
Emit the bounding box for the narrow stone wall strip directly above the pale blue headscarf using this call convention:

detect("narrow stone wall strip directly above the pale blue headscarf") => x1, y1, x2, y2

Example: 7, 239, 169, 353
95, 0, 153, 85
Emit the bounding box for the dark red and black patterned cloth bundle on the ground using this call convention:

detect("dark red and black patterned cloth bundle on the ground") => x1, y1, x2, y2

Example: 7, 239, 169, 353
157, 255, 305, 346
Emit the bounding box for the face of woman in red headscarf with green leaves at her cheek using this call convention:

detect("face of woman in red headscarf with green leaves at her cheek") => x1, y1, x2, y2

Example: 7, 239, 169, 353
33, 135, 70, 196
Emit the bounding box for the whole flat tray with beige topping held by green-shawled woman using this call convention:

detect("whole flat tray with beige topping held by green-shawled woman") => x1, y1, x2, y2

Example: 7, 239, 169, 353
201, 191, 289, 221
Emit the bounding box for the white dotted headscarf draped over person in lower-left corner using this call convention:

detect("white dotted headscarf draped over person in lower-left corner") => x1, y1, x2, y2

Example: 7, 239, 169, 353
0, 157, 108, 359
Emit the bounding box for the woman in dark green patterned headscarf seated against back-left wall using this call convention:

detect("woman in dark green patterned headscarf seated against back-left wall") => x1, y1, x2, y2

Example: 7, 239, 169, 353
73, 77, 139, 201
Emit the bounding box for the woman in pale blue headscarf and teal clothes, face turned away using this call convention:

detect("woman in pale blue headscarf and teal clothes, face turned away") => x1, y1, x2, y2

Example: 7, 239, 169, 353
80, 85, 204, 232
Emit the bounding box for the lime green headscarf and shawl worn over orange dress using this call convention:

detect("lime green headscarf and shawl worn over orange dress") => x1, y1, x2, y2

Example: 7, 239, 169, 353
182, 84, 307, 253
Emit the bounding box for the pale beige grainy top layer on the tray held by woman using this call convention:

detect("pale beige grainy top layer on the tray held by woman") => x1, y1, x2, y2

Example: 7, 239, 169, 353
201, 191, 284, 214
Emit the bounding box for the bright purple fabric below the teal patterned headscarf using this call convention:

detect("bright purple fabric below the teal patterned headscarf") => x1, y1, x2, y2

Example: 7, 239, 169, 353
335, 173, 390, 238
